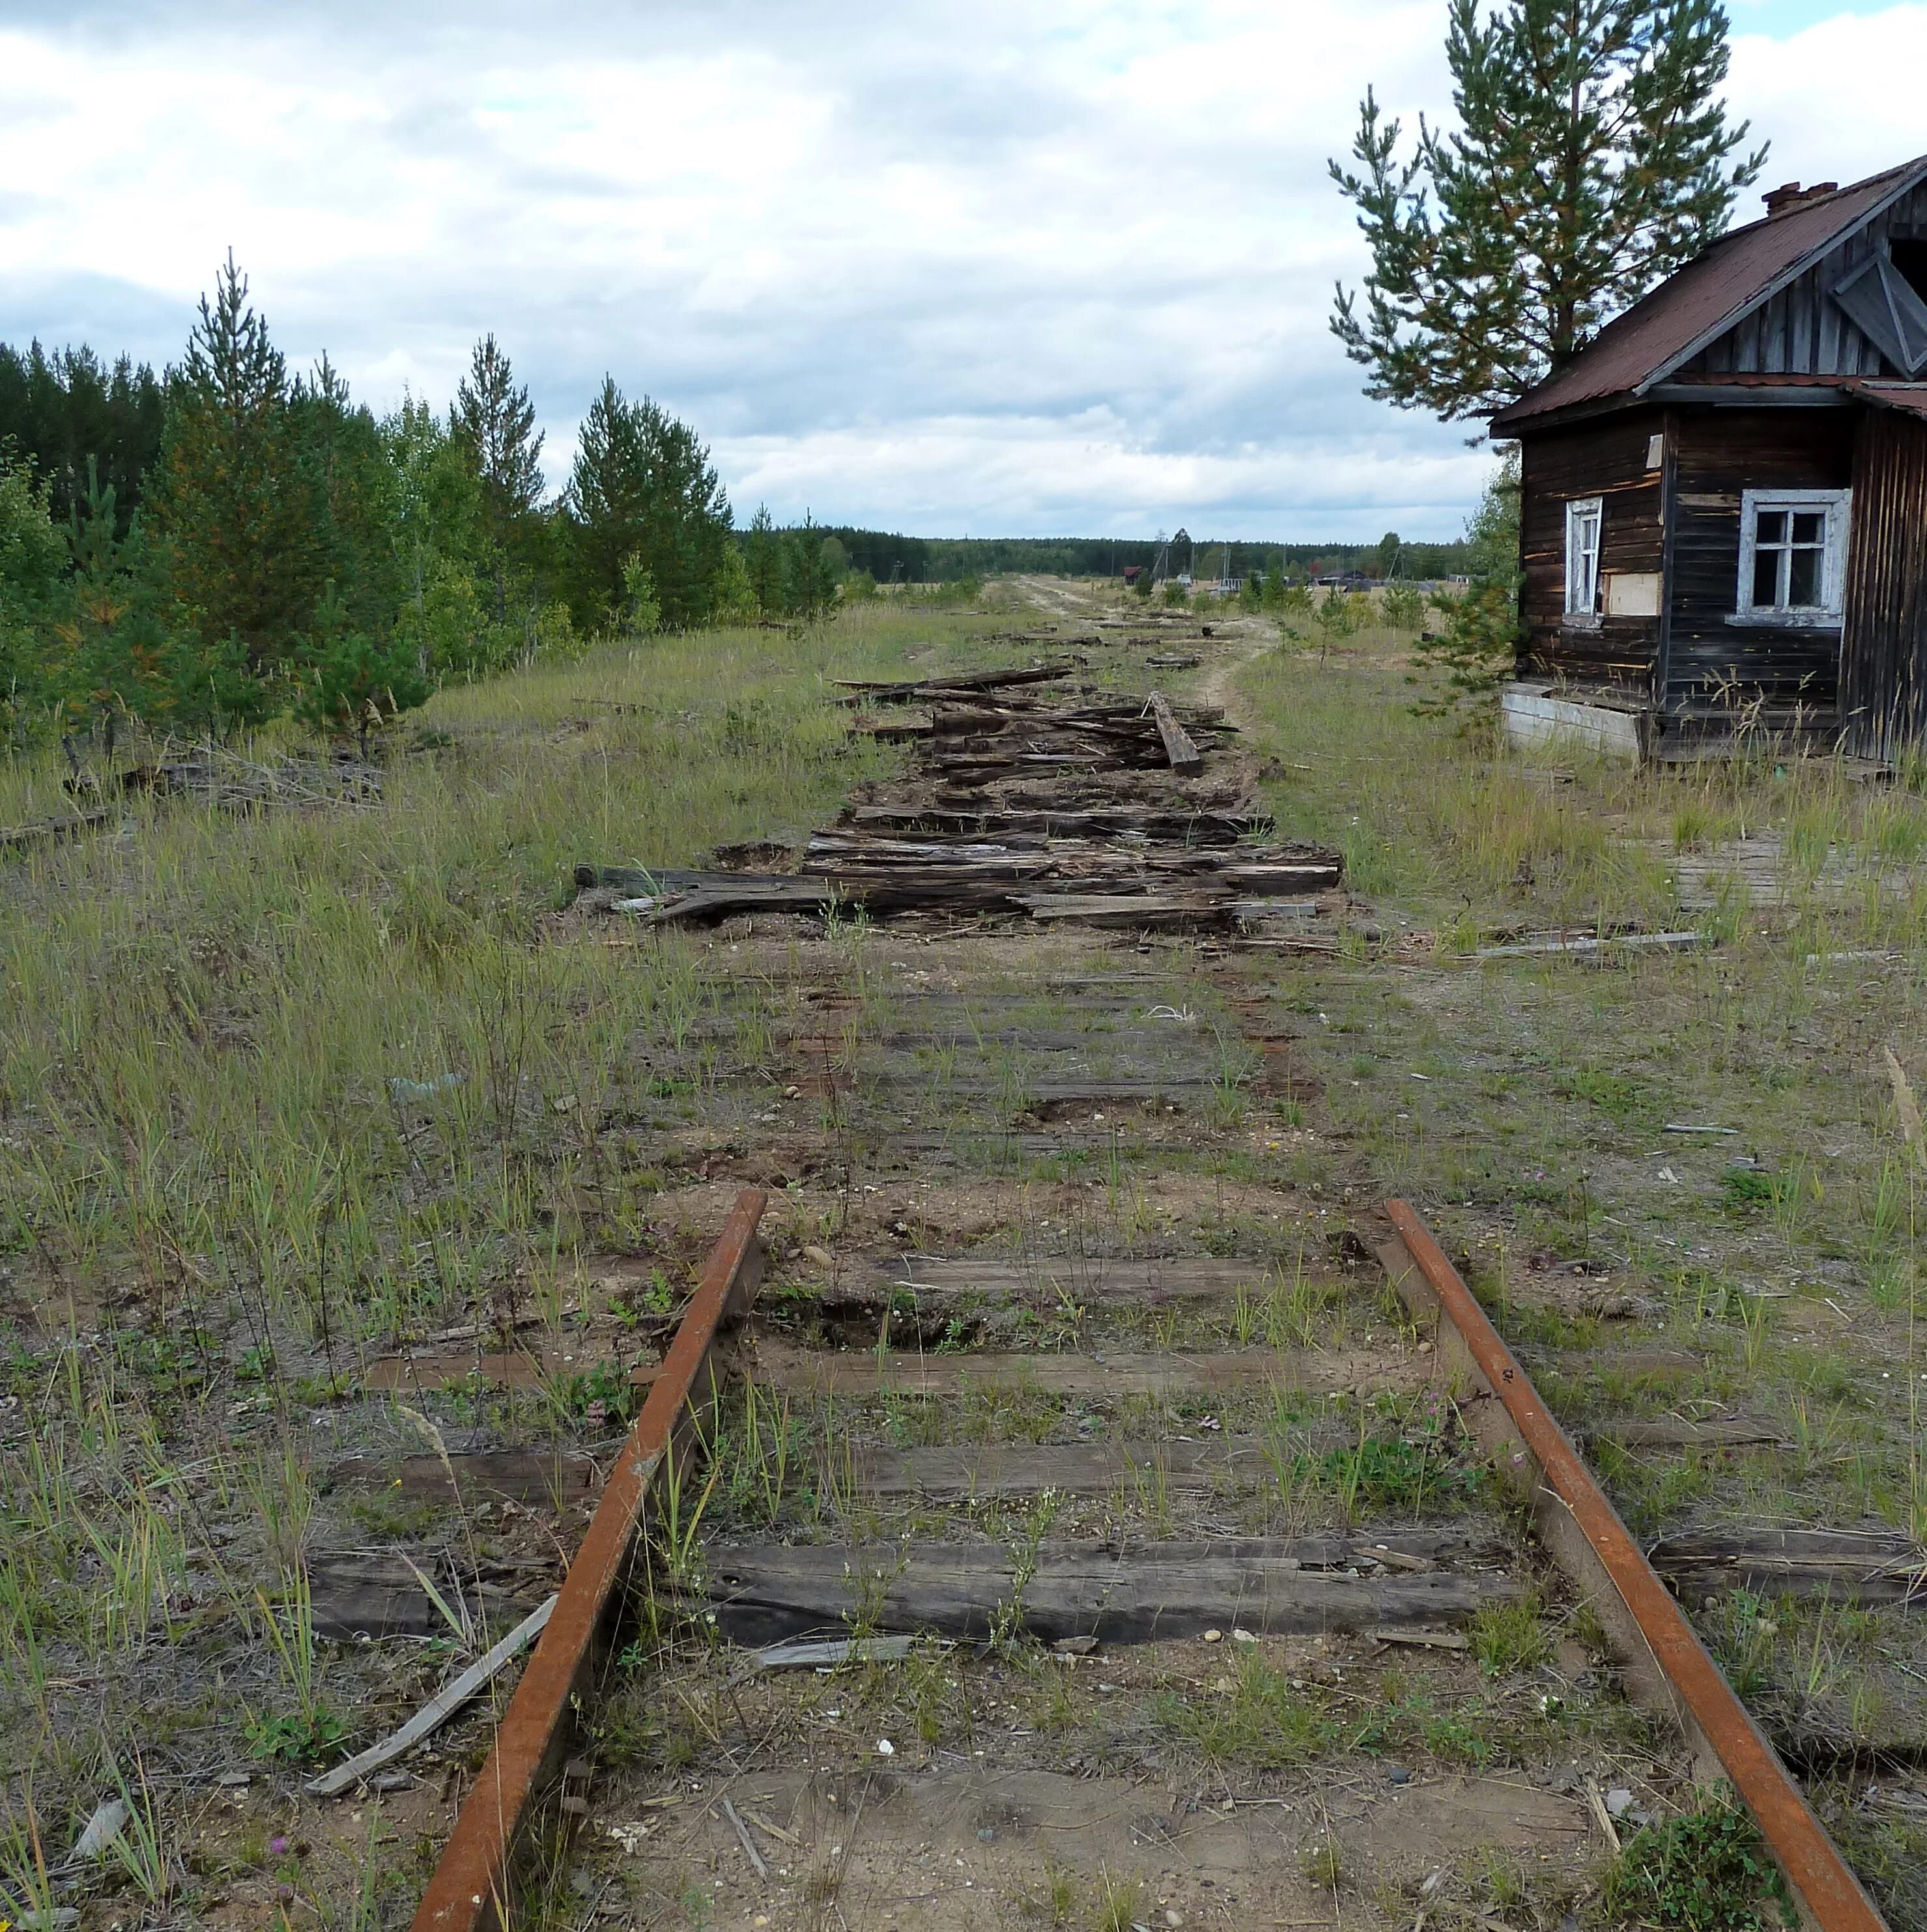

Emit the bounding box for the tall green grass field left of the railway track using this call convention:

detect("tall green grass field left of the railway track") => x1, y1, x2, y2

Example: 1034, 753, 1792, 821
0, 599, 1003, 1922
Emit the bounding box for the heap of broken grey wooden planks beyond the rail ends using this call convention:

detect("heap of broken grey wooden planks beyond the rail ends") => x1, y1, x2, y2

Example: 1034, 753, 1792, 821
576, 664, 1341, 930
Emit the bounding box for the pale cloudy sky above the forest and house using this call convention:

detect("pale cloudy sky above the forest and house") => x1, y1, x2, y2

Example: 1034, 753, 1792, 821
0, 0, 1927, 541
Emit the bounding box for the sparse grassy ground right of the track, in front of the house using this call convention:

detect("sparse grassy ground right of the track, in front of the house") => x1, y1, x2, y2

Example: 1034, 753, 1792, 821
1241, 628, 1927, 1922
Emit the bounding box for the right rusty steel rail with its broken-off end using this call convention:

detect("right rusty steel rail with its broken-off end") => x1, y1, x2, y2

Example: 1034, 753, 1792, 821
1378, 1200, 1887, 1932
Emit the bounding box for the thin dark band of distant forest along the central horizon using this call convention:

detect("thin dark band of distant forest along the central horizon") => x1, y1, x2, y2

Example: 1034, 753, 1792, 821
825, 524, 1469, 584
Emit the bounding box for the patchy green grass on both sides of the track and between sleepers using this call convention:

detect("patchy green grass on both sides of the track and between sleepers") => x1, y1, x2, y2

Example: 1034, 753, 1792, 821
0, 599, 1927, 1924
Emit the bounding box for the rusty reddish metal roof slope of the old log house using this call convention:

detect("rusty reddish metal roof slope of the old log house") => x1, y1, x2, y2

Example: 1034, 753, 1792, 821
1492, 154, 1927, 434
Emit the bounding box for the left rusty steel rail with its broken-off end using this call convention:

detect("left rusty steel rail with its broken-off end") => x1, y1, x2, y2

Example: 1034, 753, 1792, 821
412, 1188, 769, 1932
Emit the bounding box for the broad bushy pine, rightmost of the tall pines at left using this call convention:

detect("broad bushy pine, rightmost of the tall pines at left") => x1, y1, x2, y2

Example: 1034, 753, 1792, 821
566, 376, 730, 630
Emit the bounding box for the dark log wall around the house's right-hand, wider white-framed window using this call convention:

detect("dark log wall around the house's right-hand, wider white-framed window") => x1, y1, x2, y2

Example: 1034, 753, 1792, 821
1664, 408, 1861, 717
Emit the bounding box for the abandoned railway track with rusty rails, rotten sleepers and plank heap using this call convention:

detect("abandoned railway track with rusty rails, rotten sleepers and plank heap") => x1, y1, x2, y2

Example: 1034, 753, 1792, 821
398, 645, 1879, 1932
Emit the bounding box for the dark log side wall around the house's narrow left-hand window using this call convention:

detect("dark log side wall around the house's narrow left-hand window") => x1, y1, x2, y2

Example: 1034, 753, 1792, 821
1519, 408, 1666, 692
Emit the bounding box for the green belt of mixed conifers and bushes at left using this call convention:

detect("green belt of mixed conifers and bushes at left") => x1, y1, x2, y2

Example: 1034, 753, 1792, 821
0, 261, 850, 742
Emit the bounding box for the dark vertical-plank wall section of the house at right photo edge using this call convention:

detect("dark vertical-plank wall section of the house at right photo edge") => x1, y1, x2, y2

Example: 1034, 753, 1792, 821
1840, 410, 1927, 758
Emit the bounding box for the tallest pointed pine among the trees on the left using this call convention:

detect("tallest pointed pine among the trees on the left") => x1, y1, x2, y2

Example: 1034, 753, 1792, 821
149, 255, 322, 683
